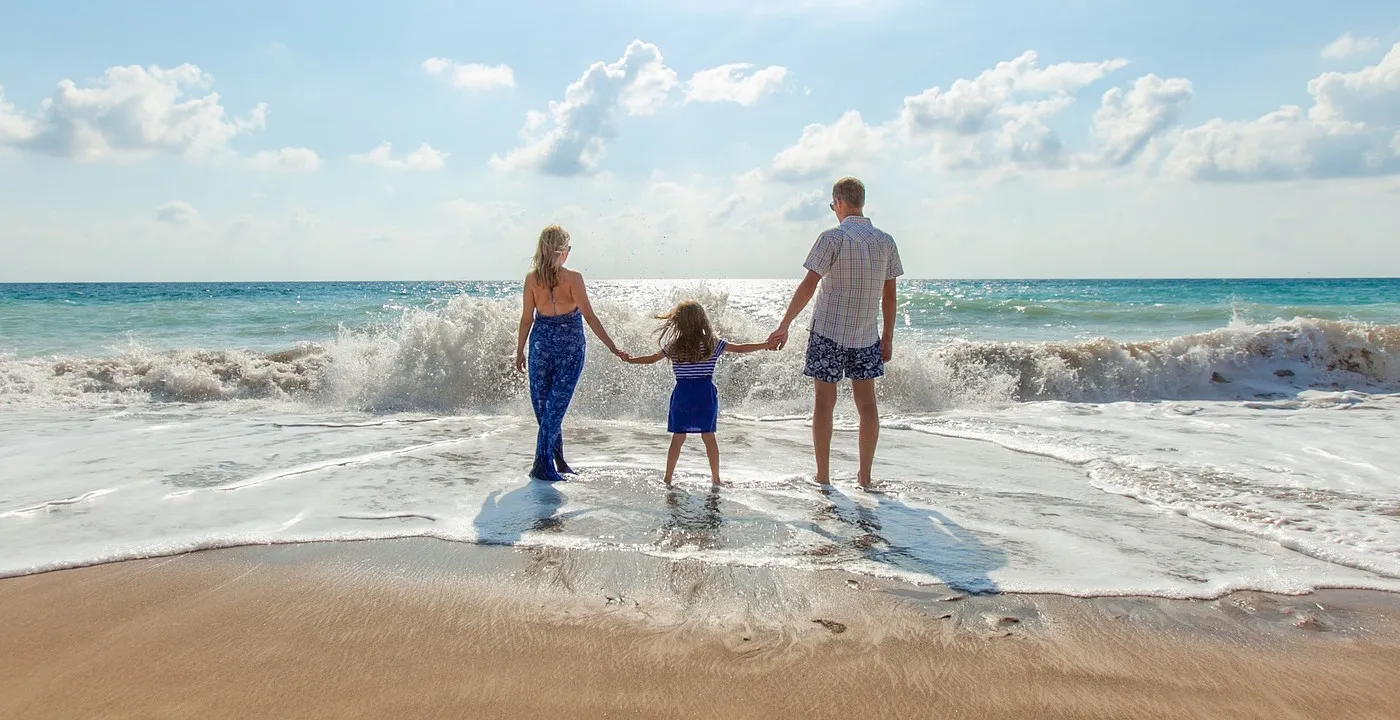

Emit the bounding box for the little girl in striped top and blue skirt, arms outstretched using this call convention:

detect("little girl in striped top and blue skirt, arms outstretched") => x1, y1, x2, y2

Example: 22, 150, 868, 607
623, 300, 769, 486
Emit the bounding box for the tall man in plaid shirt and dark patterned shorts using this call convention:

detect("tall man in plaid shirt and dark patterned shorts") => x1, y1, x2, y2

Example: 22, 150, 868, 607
769, 178, 904, 489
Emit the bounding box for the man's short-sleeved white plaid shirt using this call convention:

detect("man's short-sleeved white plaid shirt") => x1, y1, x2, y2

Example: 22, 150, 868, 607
802, 216, 904, 347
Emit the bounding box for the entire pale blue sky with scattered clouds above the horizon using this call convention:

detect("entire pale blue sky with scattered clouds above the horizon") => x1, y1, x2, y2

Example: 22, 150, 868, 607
0, 0, 1400, 282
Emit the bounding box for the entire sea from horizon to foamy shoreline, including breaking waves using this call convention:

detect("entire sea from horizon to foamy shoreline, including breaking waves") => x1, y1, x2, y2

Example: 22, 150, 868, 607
0, 279, 1400, 598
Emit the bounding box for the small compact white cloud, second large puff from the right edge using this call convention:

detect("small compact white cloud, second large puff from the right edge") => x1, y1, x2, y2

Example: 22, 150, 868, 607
1093, 74, 1193, 165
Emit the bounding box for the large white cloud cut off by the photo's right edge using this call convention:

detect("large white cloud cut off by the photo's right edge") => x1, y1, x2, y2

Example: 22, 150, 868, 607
1166, 43, 1400, 181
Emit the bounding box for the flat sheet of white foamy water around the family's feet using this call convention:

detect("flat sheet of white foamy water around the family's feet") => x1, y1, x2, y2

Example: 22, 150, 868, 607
0, 398, 1400, 597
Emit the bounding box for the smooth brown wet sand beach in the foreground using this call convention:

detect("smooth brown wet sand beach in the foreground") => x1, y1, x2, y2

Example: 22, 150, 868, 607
0, 539, 1400, 719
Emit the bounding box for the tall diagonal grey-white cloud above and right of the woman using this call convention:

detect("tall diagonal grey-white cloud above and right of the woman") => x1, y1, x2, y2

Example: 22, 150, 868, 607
490, 41, 676, 176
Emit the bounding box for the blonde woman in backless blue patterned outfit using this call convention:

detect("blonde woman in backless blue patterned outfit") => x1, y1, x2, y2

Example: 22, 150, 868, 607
515, 226, 626, 482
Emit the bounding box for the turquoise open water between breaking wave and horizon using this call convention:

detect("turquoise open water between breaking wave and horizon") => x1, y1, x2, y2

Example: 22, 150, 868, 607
0, 279, 1400, 357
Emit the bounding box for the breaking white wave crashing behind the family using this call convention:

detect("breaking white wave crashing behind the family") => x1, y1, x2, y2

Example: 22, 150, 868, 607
0, 289, 1400, 417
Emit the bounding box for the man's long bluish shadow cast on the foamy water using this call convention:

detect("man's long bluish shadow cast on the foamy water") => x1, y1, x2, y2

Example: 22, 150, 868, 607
815, 487, 1007, 595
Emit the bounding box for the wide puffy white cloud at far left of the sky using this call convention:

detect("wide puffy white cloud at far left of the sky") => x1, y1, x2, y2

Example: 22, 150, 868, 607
0, 63, 267, 161
